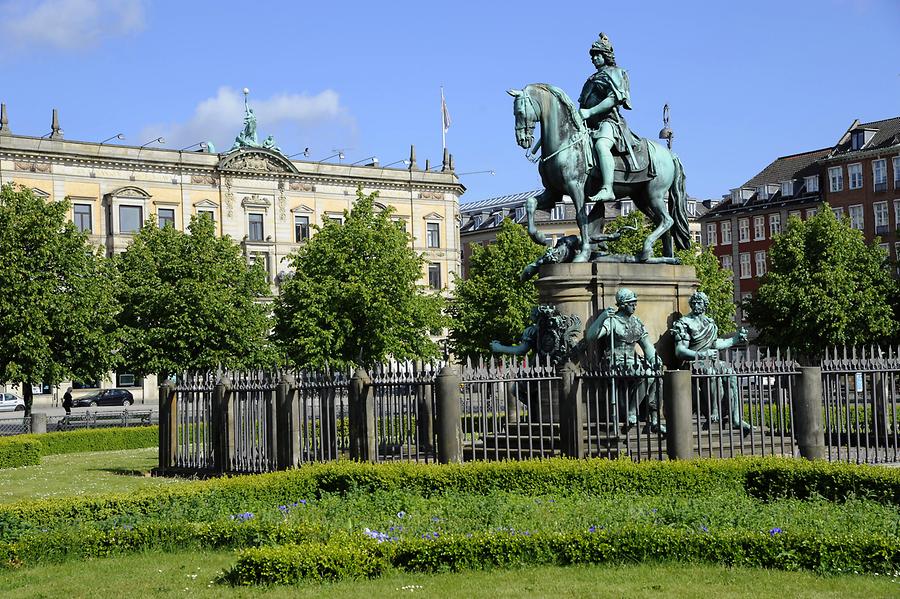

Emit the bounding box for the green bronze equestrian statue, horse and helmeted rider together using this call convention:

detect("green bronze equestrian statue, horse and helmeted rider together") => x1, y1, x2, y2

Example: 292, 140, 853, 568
508, 33, 690, 263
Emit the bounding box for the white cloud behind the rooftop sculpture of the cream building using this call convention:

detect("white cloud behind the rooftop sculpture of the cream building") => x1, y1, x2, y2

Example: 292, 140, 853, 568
140, 86, 355, 152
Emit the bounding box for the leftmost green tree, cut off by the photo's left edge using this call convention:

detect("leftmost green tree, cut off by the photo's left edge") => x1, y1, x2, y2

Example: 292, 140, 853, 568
0, 184, 119, 415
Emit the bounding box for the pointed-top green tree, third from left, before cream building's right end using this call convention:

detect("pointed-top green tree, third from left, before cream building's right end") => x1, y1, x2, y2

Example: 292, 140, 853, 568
274, 189, 445, 366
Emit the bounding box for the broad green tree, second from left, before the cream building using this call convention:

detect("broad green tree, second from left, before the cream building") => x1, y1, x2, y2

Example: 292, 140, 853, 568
116, 216, 275, 377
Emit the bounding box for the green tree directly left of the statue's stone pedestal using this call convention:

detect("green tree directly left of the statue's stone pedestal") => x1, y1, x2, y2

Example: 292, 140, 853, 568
448, 219, 546, 358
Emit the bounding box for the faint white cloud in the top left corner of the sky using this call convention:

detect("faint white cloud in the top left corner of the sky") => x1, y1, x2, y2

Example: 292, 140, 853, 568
0, 0, 144, 50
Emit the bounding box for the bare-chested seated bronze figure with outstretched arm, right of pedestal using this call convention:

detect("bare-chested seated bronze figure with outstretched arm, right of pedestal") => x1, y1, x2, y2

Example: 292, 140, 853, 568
672, 291, 752, 433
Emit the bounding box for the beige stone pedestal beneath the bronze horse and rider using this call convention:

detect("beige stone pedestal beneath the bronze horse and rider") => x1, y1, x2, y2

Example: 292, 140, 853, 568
537, 262, 699, 368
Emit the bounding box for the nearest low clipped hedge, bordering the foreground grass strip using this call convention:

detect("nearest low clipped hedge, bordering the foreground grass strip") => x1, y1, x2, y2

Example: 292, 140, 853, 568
223, 528, 900, 585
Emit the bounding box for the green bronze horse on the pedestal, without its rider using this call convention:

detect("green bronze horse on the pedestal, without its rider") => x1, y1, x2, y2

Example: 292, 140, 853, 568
507, 83, 690, 263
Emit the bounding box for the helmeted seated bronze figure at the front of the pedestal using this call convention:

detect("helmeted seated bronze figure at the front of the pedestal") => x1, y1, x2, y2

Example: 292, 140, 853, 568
582, 287, 666, 433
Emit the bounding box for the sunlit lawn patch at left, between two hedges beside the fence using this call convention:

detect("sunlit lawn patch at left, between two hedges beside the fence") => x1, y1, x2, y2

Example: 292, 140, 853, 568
0, 447, 182, 504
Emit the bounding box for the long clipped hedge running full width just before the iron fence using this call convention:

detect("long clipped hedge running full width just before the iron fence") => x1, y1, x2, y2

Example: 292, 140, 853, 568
0, 458, 900, 527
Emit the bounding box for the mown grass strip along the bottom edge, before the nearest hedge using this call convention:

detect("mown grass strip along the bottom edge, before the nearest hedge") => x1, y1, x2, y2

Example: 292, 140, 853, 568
0, 551, 900, 599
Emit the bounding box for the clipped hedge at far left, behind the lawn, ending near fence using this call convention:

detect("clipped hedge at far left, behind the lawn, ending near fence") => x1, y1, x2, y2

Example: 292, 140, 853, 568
0, 426, 159, 469
